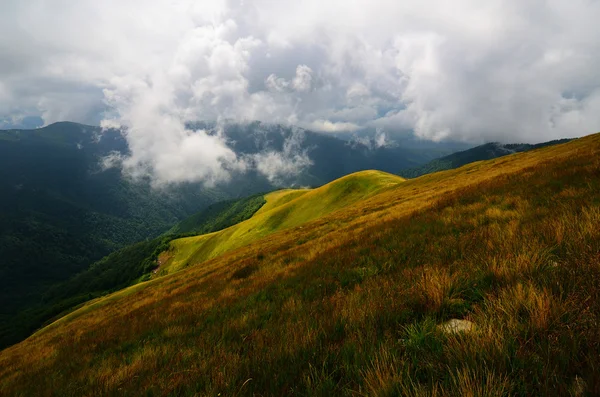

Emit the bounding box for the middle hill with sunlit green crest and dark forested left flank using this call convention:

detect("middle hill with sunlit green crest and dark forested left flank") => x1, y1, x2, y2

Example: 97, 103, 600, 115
3, 171, 402, 348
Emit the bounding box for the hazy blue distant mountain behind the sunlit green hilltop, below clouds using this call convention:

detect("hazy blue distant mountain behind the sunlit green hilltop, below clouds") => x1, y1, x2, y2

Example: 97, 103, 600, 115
189, 121, 464, 187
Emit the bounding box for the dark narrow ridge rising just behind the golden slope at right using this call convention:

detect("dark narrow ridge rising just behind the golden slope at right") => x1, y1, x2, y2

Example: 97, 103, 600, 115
399, 139, 570, 178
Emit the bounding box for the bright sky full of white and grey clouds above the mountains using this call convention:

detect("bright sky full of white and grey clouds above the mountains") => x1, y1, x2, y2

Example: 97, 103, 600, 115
0, 0, 600, 183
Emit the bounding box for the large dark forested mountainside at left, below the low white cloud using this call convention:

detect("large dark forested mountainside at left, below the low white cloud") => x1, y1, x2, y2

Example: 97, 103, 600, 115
0, 123, 238, 345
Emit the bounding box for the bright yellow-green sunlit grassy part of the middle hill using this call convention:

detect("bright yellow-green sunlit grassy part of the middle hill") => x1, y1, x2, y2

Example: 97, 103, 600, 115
160, 171, 404, 275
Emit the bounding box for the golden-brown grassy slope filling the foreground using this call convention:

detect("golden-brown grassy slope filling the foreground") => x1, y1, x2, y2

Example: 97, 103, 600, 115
0, 135, 600, 396
